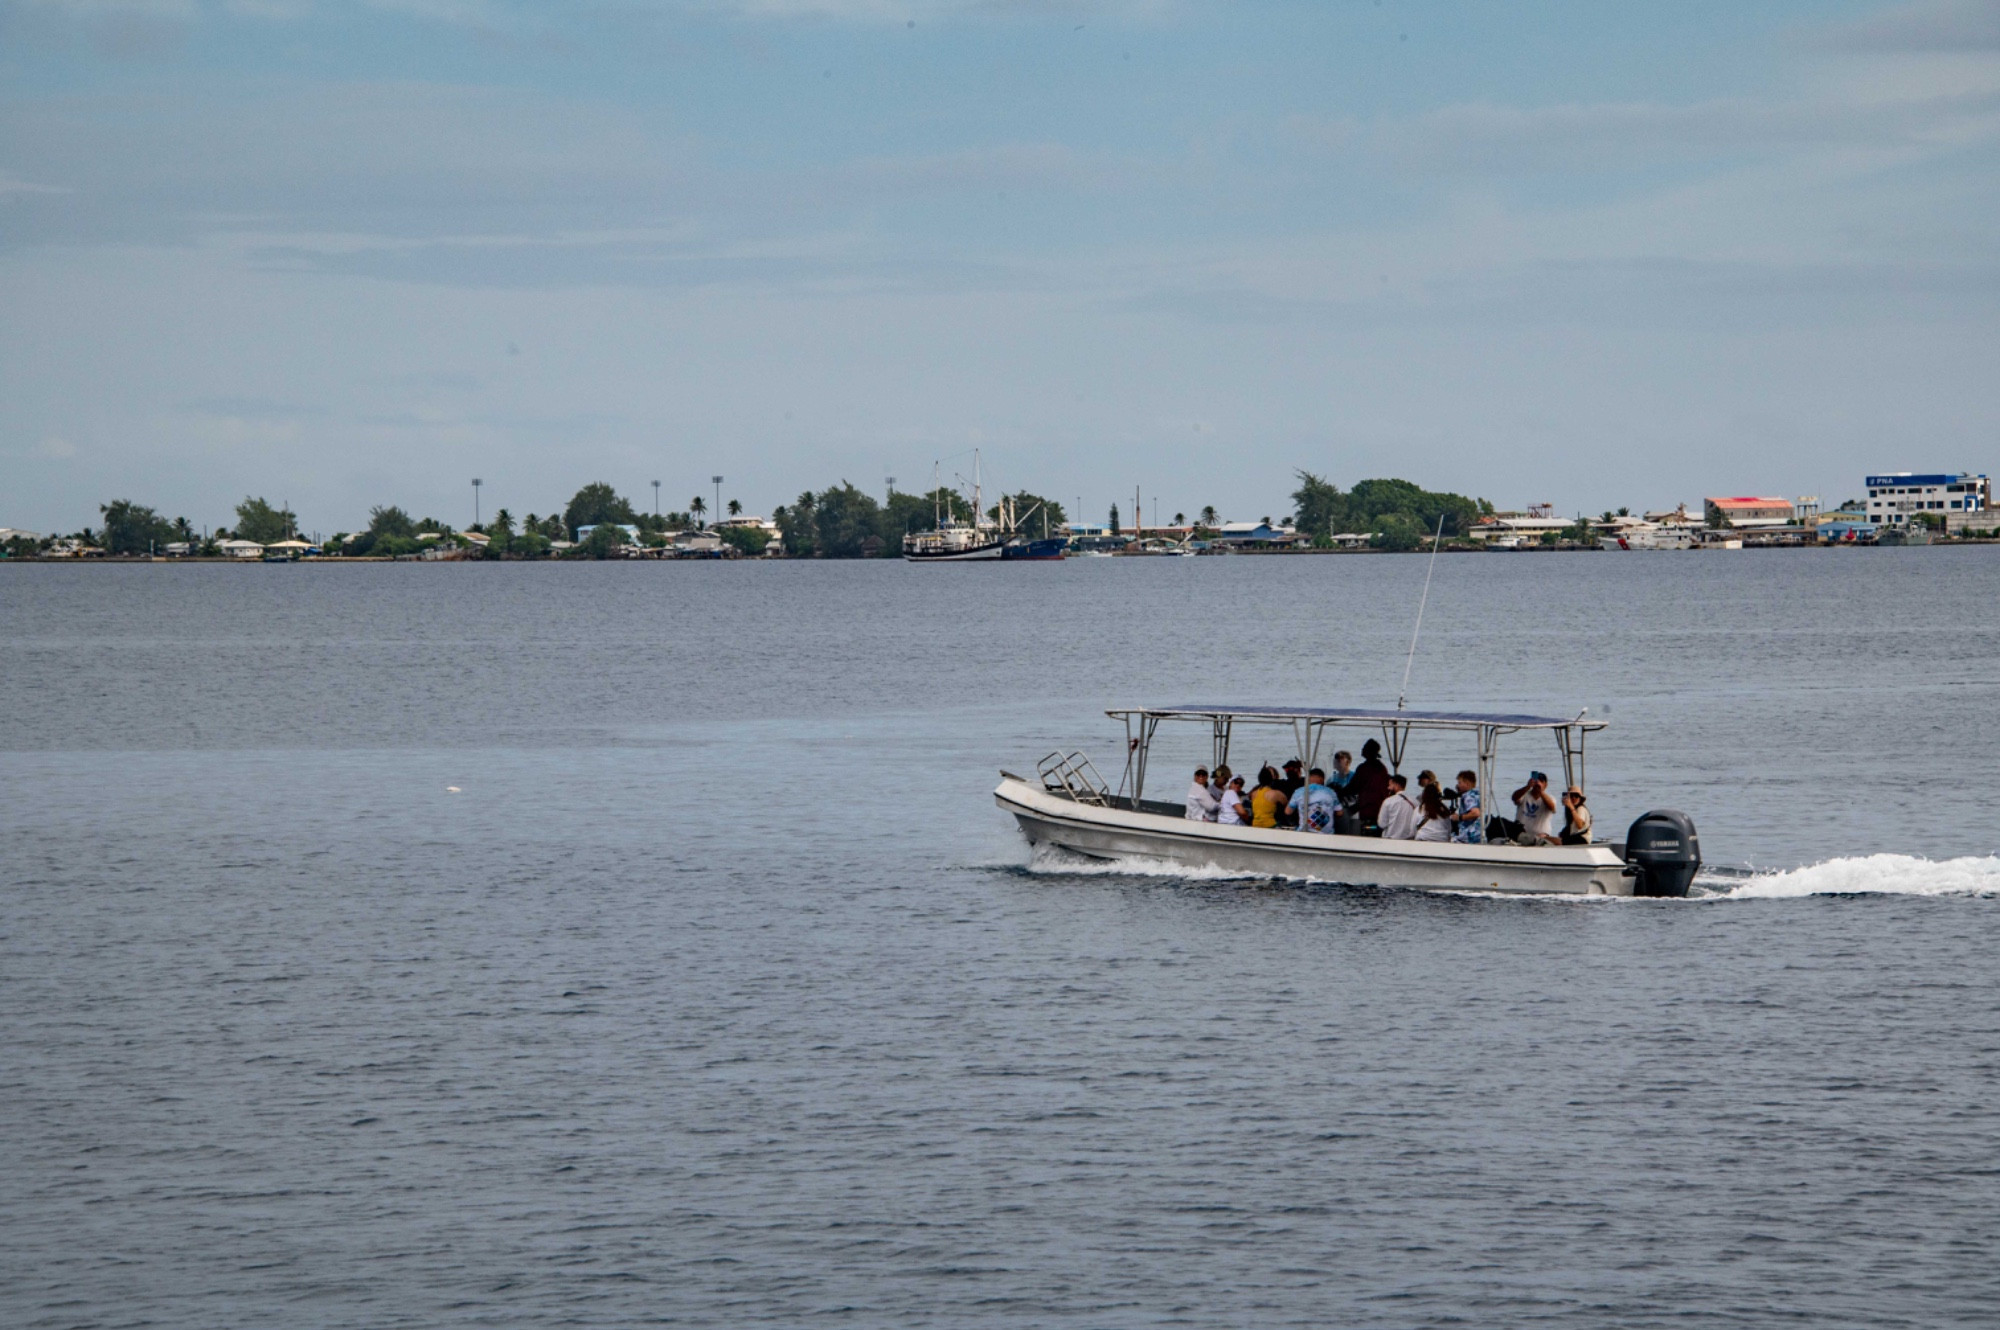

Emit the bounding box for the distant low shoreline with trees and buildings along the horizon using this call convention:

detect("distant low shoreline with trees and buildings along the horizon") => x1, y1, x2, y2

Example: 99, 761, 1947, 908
0, 470, 2000, 562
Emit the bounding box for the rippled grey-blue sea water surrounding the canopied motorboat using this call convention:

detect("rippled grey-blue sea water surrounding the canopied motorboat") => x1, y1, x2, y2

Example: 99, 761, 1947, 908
0, 548, 2000, 1328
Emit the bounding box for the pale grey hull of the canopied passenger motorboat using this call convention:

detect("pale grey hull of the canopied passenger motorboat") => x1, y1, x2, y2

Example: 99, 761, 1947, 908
994, 776, 1632, 896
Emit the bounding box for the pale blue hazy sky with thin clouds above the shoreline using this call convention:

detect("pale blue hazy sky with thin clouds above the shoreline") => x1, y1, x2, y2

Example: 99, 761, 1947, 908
0, 0, 2000, 532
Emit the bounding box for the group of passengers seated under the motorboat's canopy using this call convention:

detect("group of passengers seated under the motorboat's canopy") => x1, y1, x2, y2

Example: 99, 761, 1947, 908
1188, 740, 1590, 846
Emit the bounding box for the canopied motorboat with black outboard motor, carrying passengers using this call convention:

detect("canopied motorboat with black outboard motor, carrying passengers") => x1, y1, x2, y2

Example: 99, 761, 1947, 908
994, 706, 1702, 896
